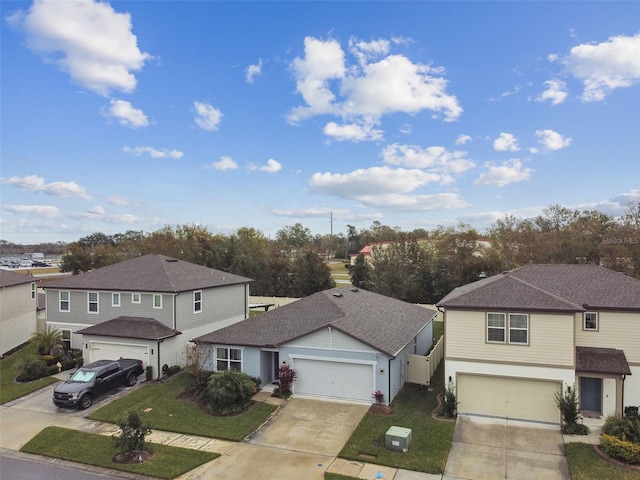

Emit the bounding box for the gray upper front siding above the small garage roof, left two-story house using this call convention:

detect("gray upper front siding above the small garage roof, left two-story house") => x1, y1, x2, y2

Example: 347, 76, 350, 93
47, 289, 173, 328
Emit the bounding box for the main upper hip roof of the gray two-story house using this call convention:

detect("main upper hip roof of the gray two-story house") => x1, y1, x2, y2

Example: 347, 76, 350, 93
42, 255, 252, 293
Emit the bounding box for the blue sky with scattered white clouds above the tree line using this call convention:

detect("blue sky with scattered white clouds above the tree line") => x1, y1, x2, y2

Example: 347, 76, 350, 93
0, 0, 640, 243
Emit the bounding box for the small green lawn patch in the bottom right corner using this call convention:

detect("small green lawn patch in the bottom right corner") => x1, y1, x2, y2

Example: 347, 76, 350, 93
564, 443, 640, 480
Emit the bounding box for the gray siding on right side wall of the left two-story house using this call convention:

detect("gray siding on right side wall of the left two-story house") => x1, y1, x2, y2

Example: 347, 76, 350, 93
175, 285, 248, 331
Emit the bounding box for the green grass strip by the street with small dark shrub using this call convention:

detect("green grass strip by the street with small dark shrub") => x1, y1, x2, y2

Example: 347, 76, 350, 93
20, 427, 220, 478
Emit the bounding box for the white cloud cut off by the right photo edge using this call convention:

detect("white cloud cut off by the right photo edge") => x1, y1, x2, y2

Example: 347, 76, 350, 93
563, 33, 640, 102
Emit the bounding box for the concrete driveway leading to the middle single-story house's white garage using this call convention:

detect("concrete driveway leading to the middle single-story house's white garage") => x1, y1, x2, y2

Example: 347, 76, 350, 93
180, 398, 369, 480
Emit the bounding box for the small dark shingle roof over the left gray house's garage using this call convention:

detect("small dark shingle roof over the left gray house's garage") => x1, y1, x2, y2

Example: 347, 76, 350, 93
76, 317, 182, 340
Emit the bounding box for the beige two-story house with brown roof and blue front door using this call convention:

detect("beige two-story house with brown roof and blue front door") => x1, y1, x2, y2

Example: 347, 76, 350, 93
438, 265, 640, 423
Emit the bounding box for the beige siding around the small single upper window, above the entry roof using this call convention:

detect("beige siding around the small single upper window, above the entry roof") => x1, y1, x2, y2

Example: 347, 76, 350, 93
575, 310, 640, 365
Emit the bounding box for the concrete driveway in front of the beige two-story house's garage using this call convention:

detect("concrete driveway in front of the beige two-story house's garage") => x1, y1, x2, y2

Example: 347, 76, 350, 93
444, 415, 571, 480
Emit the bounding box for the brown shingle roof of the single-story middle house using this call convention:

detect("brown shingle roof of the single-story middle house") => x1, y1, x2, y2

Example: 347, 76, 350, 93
193, 287, 437, 356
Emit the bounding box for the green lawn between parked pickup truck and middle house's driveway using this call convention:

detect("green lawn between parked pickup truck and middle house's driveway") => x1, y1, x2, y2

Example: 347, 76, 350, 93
89, 372, 276, 442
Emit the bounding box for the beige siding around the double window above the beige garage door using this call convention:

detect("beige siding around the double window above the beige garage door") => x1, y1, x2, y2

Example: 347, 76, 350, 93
445, 309, 574, 366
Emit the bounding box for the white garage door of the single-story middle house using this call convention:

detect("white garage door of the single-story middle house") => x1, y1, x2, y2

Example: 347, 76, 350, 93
292, 358, 375, 403
